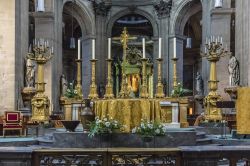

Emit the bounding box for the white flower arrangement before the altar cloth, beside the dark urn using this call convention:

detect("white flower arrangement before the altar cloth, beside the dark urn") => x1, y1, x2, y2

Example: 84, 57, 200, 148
88, 116, 125, 137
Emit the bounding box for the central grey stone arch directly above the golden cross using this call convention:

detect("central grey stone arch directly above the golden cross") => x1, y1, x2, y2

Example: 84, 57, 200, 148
107, 9, 159, 36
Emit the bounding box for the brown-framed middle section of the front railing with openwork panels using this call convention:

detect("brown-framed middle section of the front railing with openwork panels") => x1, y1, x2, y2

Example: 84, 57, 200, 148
33, 148, 181, 166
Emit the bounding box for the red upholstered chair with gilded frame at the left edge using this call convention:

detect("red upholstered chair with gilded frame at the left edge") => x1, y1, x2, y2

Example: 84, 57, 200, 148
3, 111, 23, 136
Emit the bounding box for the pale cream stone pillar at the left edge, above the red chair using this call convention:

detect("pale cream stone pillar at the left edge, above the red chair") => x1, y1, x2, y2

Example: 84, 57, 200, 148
0, 0, 17, 115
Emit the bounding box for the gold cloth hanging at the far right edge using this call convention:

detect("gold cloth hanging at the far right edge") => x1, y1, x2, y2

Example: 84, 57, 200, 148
236, 87, 250, 134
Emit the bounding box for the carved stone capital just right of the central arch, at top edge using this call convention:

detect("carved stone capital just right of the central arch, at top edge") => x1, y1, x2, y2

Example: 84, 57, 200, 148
154, 0, 172, 18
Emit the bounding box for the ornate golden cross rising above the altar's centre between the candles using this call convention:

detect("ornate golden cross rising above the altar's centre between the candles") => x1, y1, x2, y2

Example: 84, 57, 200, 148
113, 27, 137, 59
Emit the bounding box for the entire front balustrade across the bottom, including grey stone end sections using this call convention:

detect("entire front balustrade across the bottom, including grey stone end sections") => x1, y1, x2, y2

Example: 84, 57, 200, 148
0, 146, 250, 166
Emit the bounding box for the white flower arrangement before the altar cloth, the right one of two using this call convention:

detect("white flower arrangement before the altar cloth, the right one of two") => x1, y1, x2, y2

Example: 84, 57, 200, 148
132, 119, 166, 137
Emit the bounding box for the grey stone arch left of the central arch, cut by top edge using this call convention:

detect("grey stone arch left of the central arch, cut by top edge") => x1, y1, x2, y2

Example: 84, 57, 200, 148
60, 0, 95, 35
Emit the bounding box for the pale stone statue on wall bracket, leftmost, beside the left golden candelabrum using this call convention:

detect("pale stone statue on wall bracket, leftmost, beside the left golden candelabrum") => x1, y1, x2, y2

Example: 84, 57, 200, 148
25, 58, 35, 87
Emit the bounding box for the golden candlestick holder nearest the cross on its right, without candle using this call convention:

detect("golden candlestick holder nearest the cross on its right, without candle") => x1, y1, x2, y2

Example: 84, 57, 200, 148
140, 58, 149, 98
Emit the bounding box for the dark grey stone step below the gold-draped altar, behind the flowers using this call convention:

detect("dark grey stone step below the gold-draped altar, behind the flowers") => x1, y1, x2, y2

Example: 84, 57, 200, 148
52, 129, 196, 148
